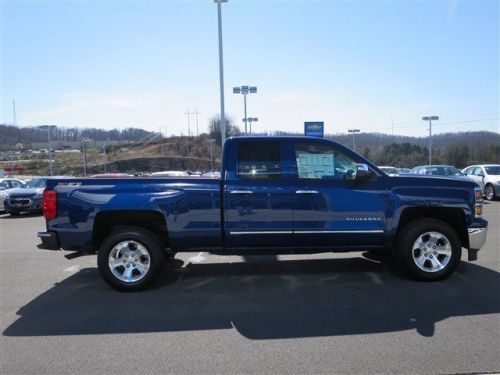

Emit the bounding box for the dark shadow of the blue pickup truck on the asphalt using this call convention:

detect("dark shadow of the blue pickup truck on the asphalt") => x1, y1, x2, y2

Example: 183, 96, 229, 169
3, 258, 500, 340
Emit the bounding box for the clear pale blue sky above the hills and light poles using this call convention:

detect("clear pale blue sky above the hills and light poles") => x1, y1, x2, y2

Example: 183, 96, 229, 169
0, 0, 500, 136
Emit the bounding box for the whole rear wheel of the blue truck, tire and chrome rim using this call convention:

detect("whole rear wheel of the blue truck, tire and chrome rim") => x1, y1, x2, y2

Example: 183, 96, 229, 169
97, 226, 162, 292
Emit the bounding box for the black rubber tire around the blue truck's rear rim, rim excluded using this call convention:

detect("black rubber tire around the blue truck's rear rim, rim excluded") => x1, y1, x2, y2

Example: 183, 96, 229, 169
97, 226, 163, 292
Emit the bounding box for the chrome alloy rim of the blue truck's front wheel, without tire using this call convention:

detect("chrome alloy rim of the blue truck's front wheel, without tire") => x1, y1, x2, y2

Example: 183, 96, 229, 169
412, 232, 451, 272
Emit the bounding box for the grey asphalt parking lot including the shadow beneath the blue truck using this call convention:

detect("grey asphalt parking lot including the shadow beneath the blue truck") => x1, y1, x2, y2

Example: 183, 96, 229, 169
0, 202, 500, 374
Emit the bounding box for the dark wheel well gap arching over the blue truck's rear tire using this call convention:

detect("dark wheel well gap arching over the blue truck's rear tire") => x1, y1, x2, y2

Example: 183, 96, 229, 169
92, 211, 169, 251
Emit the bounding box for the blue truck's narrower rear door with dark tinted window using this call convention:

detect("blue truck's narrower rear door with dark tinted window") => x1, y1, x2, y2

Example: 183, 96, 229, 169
224, 139, 293, 249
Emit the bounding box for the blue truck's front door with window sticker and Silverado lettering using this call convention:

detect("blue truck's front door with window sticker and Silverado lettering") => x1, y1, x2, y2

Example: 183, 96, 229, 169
290, 140, 388, 248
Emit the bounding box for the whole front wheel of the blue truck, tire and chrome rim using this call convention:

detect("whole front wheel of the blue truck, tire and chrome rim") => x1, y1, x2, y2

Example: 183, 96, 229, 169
397, 218, 462, 281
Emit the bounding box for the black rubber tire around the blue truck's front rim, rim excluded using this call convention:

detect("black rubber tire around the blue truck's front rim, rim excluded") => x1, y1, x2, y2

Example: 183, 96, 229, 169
396, 218, 462, 281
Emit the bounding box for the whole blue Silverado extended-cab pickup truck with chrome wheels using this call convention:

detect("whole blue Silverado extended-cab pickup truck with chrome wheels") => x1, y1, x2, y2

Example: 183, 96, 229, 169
38, 137, 488, 291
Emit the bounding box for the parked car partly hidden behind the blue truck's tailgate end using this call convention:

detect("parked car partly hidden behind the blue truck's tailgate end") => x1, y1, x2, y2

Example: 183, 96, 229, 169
4, 176, 71, 216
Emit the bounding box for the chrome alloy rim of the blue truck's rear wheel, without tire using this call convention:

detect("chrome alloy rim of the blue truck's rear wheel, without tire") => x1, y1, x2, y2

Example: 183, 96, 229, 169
108, 241, 151, 283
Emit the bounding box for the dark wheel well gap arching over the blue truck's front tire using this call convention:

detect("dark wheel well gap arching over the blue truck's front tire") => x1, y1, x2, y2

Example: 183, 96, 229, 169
398, 207, 469, 248
